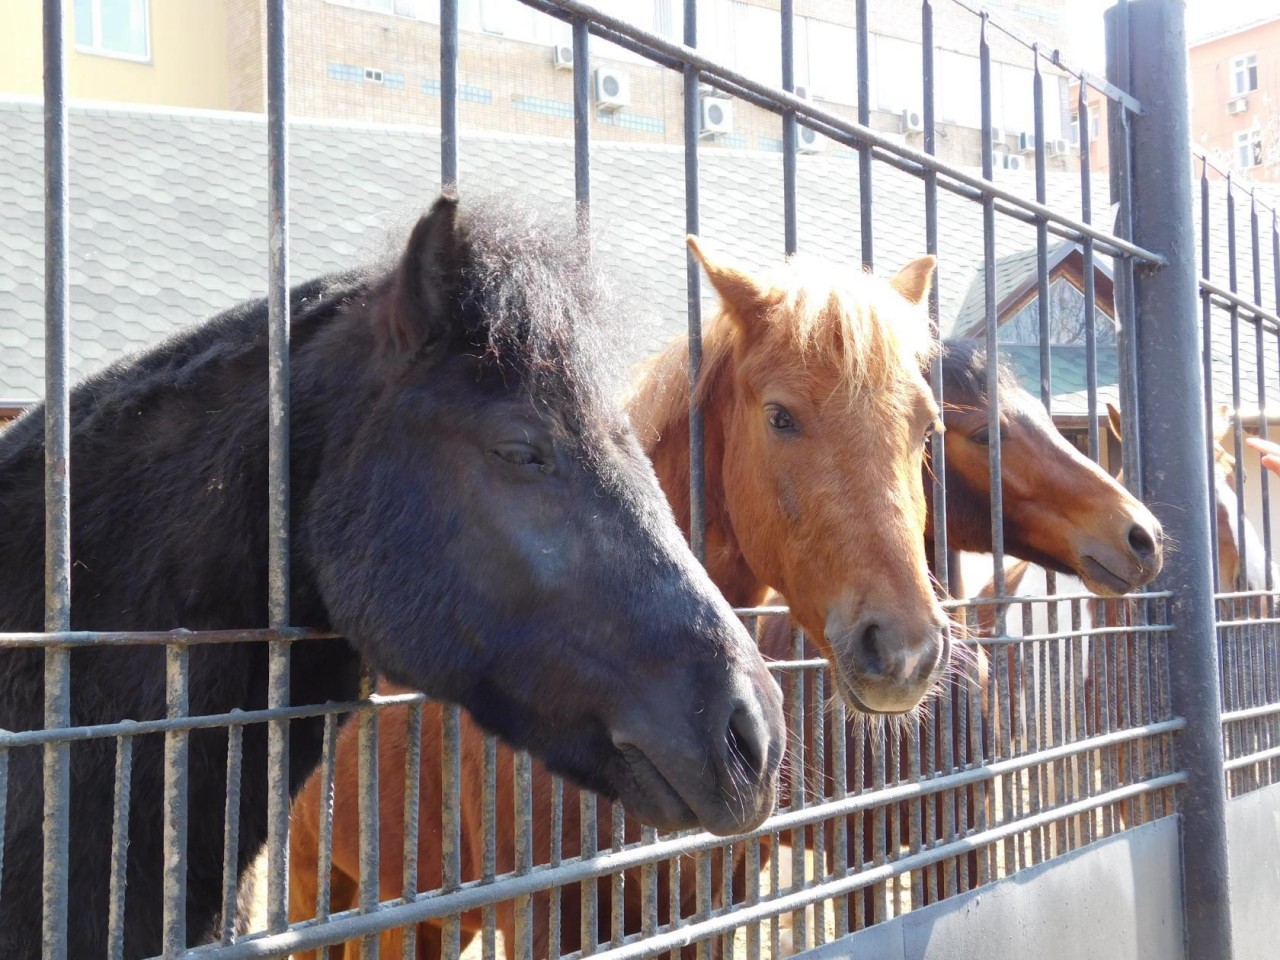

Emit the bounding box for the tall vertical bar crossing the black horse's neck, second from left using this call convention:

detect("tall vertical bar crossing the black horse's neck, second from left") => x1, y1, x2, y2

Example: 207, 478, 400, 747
266, 0, 289, 933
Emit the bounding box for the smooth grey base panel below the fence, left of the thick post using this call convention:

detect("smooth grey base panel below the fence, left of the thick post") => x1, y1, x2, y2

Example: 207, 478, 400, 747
799, 819, 1182, 960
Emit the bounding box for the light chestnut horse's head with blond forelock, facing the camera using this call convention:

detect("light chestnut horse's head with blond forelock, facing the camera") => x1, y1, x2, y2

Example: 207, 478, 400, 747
689, 238, 950, 713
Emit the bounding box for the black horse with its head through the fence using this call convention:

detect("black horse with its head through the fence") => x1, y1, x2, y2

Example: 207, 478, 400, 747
0, 196, 783, 959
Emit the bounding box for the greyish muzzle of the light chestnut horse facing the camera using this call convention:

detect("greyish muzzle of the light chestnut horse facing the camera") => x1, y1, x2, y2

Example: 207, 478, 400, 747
827, 612, 951, 713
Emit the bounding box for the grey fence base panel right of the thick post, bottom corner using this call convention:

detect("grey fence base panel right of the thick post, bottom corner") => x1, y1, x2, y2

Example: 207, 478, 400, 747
1226, 785, 1280, 960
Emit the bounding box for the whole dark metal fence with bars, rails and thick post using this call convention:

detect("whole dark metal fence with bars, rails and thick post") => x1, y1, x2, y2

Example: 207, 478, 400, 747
0, 0, 1280, 960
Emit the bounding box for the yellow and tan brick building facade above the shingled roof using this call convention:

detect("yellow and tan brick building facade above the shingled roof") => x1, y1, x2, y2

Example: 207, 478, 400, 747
0, 0, 1074, 170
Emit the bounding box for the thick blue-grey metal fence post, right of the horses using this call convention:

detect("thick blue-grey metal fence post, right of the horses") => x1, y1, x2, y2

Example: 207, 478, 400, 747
1106, 0, 1231, 960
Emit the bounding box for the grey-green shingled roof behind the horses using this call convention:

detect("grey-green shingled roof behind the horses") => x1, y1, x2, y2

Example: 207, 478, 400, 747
0, 100, 1280, 422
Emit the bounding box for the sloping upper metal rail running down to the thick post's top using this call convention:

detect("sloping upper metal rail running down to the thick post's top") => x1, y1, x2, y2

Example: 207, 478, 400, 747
520, 0, 1165, 266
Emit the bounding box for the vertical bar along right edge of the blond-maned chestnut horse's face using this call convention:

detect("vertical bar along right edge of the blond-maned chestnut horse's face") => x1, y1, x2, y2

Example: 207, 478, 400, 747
921, 0, 959, 593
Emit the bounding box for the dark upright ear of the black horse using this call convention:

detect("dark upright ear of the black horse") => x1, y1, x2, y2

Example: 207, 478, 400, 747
376, 191, 465, 353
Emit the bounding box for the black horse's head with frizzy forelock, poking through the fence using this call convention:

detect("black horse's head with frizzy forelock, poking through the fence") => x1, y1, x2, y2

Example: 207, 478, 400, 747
302, 196, 783, 833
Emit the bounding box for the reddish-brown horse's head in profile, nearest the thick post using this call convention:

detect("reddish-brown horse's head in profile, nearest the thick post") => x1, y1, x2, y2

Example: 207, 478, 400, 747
942, 340, 1164, 596
